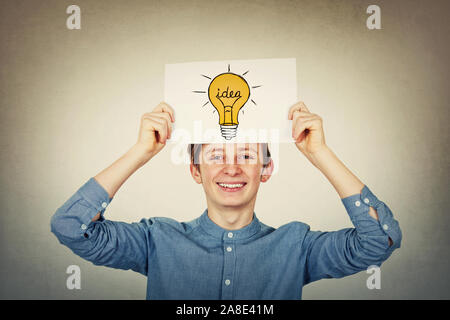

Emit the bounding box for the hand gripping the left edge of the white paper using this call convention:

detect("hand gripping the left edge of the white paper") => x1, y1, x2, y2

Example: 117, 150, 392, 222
136, 102, 175, 157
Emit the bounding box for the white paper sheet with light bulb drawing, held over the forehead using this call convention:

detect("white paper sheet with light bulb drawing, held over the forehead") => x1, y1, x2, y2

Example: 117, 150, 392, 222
164, 59, 297, 143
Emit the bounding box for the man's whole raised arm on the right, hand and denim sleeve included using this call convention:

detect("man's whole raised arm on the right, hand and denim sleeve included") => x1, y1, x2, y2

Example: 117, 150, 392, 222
288, 102, 402, 283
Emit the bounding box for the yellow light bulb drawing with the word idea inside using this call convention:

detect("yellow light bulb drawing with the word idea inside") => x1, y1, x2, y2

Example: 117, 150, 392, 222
208, 72, 250, 140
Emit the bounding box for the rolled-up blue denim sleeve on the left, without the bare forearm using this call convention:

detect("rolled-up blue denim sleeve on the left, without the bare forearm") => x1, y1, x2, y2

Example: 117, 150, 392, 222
50, 178, 151, 275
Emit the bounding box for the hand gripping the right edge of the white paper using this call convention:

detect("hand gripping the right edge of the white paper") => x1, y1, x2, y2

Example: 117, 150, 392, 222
288, 101, 327, 160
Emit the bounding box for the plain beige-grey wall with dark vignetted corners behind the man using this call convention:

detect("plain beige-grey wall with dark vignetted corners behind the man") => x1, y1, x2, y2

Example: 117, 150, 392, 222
0, 0, 450, 299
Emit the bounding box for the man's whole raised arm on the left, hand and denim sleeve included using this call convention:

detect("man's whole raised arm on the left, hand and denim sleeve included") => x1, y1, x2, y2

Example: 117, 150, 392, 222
51, 104, 174, 274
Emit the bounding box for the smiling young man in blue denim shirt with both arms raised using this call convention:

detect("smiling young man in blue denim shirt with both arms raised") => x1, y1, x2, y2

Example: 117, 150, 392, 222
51, 102, 402, 299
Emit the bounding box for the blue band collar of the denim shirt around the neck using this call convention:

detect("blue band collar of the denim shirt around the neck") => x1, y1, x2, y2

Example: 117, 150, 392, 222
199, 209, 261, 240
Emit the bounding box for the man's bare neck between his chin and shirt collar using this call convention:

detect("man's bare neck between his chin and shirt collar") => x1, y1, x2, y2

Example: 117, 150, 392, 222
208, 201, 255, 230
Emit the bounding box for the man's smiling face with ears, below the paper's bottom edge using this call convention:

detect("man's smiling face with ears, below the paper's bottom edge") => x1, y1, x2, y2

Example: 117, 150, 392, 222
190, 143, 273, 210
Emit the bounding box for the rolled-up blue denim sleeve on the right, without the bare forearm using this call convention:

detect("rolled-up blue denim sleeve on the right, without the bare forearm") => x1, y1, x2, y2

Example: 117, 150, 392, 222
302, 186, 402, 284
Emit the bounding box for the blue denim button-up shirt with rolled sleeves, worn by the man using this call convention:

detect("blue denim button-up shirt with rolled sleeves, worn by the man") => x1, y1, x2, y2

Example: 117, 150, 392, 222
51, 178, 402, 300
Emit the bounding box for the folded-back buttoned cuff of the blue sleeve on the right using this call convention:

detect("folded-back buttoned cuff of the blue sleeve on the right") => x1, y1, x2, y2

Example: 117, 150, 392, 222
342, 186, 402, 249
